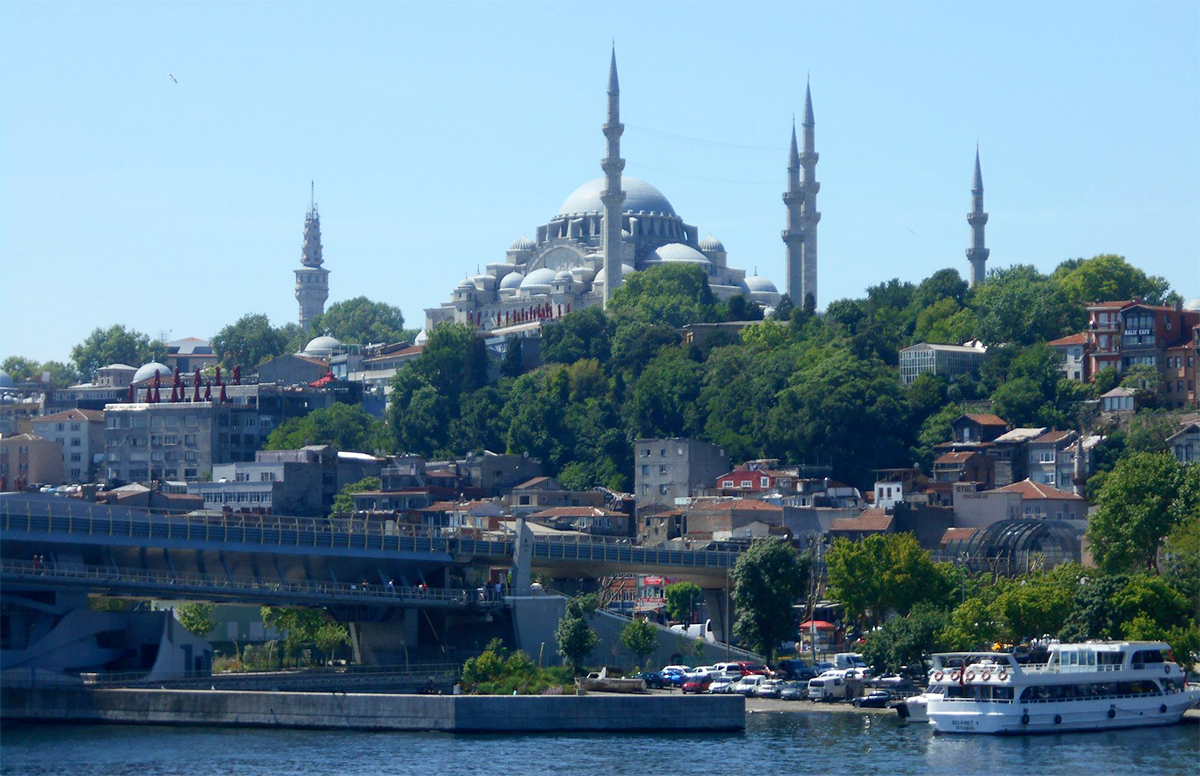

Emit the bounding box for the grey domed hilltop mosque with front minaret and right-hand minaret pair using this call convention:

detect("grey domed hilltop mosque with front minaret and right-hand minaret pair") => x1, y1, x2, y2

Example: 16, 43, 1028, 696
425, 53, 818, 336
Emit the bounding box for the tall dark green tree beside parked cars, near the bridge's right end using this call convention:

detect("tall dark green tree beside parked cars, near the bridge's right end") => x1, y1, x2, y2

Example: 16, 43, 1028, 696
730, 540, 809, 658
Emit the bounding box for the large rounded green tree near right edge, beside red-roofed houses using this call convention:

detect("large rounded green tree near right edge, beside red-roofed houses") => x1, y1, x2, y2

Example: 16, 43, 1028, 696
1087, 452, 1187, 572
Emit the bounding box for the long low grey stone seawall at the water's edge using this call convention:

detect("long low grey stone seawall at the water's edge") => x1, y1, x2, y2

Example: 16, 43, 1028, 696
0, 687, 745, 733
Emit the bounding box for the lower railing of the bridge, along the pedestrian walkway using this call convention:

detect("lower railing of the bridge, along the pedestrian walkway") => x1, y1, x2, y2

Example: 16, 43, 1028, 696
0, 560, 503, 608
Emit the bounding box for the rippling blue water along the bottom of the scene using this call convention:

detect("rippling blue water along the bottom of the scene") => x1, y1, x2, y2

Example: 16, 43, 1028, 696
0, 712, 1200, 776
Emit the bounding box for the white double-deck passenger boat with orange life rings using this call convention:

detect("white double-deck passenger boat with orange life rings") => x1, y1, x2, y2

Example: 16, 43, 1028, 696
925, 642, 1200, 735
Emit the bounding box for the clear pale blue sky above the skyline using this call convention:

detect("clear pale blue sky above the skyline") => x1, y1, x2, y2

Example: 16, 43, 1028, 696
0, 2, 1200, 360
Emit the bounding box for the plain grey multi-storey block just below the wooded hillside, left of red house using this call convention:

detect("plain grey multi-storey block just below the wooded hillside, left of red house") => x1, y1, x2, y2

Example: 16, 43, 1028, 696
634, 438, 730, 513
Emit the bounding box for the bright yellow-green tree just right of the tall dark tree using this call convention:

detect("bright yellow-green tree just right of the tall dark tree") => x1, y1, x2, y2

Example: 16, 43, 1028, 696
826, 533, 953, 624
